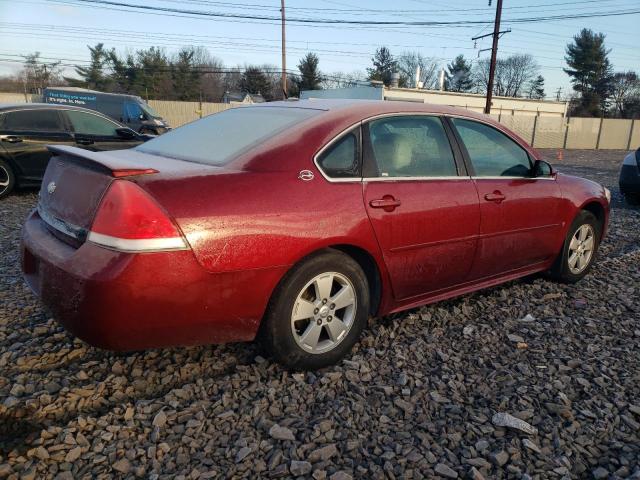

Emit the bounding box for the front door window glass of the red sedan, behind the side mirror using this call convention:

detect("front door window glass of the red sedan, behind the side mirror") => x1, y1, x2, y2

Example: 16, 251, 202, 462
451, 118, 531, 177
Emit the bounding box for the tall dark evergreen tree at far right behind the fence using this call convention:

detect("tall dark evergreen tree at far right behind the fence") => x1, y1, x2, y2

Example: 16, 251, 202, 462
564, 28, 613, 116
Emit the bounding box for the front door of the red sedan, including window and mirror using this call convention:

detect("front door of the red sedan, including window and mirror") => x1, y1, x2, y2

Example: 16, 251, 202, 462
451, 118, 562, 279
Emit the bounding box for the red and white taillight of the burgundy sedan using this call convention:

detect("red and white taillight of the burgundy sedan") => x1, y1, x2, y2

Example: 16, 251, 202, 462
87, 180, 187, 252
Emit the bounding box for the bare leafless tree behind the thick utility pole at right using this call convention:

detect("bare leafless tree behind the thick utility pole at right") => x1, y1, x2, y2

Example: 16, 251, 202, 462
473, 54, 538, 97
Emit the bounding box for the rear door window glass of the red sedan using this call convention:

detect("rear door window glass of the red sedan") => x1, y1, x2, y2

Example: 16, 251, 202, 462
369, 115, 458, 177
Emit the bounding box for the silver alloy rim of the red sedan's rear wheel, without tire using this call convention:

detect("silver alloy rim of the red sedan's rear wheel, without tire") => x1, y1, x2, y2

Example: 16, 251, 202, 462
291, 272, 357, 354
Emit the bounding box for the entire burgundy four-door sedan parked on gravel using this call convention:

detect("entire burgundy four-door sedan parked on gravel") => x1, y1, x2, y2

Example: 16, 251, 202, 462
22, 100, 609, 368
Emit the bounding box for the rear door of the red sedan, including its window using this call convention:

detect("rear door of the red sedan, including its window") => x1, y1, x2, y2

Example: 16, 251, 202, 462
363, 115, 480, 300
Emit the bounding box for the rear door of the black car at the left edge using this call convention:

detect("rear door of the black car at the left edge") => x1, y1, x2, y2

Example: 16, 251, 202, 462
0, 108, 73, 181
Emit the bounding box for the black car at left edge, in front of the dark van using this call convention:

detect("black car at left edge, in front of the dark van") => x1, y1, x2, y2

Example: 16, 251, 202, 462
0, 103, 153, 198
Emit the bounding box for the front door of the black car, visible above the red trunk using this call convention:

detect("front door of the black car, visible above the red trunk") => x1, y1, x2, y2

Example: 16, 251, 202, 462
64, 110, 142, 151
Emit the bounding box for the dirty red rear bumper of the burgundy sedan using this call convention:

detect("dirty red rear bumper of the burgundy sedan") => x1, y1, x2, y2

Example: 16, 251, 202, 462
21, 211, 284, 351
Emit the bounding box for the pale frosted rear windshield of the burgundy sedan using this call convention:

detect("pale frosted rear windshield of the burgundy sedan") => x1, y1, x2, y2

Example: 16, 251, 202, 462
136, 107, 320, 165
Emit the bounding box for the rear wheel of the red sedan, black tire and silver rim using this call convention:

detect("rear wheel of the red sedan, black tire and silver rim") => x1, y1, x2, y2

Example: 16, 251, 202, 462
261, 249, 370, 370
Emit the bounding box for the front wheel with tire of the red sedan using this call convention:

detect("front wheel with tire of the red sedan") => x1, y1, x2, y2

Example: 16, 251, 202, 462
551, 210, 601, 283
